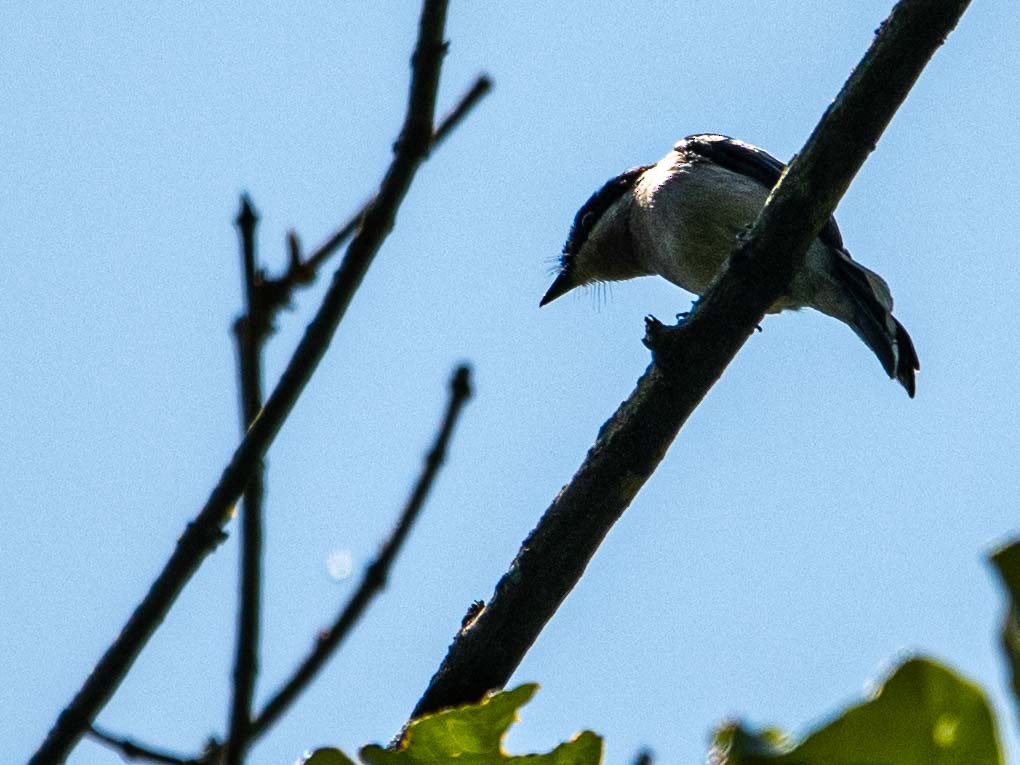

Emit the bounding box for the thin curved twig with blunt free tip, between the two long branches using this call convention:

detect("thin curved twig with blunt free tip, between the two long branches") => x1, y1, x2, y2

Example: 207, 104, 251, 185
244, 366, 471, 741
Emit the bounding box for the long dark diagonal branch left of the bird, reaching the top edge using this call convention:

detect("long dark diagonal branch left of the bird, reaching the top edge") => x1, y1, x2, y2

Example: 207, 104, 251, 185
30, 0, 448, 765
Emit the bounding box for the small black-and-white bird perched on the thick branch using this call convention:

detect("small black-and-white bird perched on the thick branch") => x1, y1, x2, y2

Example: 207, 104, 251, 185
540, 134, 921, 398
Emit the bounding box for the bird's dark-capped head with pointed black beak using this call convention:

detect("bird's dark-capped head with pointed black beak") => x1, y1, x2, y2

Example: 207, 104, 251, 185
539, 165, 652, 306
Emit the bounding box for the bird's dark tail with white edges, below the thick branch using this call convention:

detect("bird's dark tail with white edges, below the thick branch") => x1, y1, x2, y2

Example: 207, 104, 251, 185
834, 258, 921, 398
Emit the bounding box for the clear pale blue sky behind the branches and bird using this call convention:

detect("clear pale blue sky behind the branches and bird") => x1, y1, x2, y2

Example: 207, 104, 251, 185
0, 0, 1020, 765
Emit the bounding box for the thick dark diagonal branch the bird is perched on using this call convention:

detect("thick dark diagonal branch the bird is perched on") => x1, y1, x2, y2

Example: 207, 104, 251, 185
412, 0, 968, 717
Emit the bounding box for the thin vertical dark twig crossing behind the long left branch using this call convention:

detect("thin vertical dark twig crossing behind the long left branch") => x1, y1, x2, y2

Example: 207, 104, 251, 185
223, 195, 271, 765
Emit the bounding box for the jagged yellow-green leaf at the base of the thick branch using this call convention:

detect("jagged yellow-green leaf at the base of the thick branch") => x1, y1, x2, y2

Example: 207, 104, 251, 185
361, 684, 602, 765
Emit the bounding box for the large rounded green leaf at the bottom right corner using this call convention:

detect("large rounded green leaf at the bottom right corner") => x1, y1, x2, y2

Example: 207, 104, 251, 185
714, 658, 1003, 765
